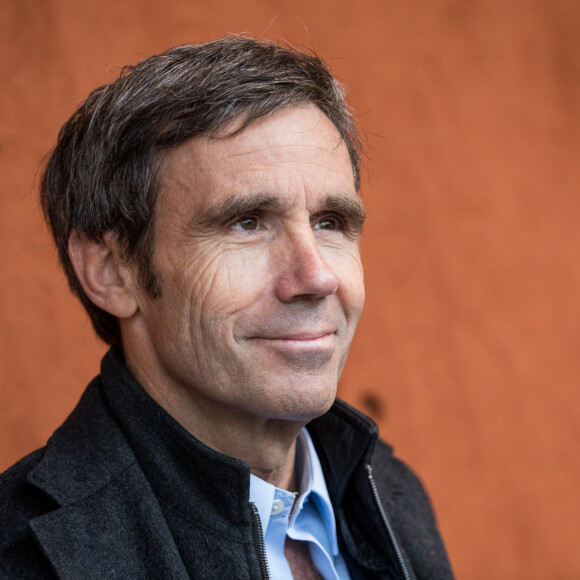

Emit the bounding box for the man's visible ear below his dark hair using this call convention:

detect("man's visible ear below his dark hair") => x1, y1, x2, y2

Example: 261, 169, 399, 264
68, 231, 138, 318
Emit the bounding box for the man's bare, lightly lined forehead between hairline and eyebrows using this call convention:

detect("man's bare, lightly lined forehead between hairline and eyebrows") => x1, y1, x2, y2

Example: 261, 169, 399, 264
158, 105, 356, 209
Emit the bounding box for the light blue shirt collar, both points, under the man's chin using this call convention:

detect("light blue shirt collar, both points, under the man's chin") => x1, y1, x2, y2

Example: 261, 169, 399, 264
250, 428, 339, 556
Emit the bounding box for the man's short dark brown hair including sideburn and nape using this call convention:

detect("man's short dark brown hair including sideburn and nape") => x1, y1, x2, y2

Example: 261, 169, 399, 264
41, 37, 360, 348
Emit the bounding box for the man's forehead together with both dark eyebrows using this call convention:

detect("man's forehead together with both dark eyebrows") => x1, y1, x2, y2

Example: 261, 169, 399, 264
158, 106, 365, 234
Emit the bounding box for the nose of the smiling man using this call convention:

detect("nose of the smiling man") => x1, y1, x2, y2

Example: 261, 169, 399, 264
273, 228, 338, 302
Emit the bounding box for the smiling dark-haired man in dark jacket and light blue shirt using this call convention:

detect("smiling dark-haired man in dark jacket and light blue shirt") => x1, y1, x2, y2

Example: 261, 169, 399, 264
0, 38, 451, 579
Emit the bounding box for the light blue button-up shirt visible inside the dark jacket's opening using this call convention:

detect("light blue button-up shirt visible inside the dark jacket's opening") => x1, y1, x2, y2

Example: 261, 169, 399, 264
250, 429, 350, 580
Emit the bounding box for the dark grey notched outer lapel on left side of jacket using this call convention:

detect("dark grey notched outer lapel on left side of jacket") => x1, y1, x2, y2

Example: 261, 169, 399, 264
28, 370, 189, 579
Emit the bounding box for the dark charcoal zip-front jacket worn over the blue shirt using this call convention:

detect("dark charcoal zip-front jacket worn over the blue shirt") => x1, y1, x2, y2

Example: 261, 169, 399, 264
0, 352, 452, 580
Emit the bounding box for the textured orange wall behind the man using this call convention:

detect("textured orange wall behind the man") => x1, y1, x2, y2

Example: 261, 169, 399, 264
0, 0, 580, 580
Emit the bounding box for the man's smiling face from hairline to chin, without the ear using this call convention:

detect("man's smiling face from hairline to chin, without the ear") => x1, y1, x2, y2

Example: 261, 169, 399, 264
134, 105, 364, 421
